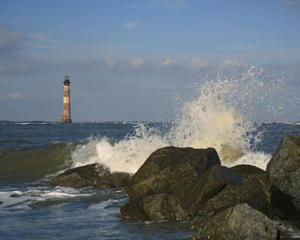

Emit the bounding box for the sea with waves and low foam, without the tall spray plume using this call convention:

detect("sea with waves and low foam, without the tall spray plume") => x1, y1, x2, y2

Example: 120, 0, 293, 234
0, 121, 300, 240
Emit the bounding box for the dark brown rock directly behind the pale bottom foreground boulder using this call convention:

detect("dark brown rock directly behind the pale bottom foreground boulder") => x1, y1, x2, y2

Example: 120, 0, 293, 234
204, 174, 273, 216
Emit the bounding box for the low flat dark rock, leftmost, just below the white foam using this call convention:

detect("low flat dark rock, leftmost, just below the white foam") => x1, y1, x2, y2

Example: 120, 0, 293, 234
51, 164, 130, 188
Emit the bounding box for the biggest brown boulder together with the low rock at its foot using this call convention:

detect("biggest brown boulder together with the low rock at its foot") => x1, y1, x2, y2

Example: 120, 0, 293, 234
121, 147, 242, 220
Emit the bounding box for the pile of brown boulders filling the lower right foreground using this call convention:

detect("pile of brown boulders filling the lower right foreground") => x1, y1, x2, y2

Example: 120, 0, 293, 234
120, 136, 300, 240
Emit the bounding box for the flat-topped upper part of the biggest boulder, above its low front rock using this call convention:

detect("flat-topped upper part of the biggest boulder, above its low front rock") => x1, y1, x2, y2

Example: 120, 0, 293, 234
126, 147, 221, 200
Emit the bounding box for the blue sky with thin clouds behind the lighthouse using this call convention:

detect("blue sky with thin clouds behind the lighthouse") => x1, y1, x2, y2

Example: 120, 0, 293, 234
0, 0, 300, 121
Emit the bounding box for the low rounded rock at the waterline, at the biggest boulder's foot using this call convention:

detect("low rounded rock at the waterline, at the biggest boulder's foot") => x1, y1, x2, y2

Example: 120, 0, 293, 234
121, 194, 188, 220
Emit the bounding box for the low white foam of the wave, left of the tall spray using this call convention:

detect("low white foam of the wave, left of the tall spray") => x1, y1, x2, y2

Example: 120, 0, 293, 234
71, 124, 170, 173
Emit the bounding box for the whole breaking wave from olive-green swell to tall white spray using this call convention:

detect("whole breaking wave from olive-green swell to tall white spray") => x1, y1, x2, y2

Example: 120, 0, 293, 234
0, 66, 299, 179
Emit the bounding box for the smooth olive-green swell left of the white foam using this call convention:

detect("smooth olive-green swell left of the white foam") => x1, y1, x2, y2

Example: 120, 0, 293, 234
0, 142, 75, 183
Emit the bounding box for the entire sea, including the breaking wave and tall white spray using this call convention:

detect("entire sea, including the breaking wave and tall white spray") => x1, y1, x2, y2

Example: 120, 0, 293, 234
0, 66, 300, 240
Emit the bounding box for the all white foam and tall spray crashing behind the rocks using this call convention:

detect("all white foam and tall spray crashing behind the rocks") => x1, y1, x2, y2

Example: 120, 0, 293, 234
72, 66, 298, 174
